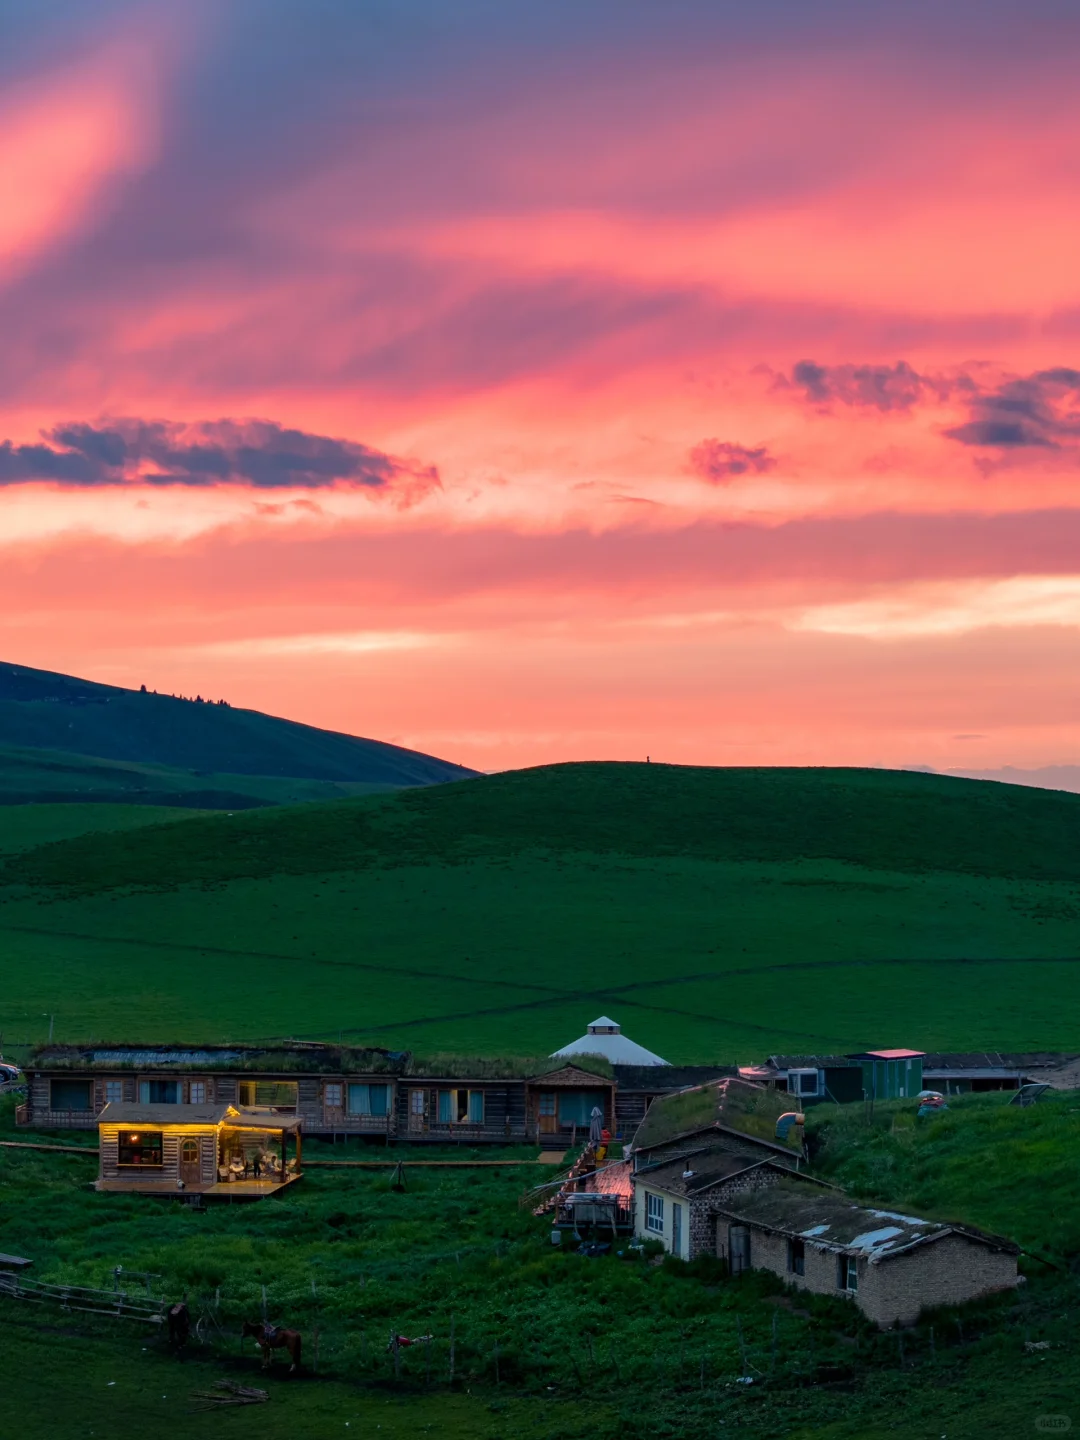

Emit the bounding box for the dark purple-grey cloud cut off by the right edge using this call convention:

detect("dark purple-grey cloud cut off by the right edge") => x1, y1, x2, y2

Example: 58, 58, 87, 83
945, 366, 1080, 449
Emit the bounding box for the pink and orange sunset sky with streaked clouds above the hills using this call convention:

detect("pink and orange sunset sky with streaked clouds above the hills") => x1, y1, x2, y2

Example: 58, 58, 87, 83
0, 0, 1080, 769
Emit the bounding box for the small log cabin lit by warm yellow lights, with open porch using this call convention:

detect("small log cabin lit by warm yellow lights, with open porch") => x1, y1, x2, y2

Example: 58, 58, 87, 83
96, 1103, 301, 1200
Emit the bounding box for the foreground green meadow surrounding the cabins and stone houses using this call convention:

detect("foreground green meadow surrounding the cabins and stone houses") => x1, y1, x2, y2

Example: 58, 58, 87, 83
0, 1094, 1080, 1440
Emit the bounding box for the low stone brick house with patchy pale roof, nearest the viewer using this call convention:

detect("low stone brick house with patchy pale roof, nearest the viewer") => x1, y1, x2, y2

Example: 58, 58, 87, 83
710, 1175, 1020, 1328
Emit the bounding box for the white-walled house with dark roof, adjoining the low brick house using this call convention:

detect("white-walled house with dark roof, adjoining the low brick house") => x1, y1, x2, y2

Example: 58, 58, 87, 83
632, 1136, 831, 1260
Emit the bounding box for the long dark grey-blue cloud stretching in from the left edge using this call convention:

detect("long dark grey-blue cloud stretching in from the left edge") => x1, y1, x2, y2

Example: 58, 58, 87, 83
0, 419, 439, 491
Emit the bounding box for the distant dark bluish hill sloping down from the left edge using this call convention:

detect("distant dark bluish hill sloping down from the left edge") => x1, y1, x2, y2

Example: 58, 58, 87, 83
0, 664, 472, 808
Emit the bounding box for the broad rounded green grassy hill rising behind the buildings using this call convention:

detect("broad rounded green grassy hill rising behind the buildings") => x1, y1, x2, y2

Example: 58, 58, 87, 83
0, 765, 1080, 1061
